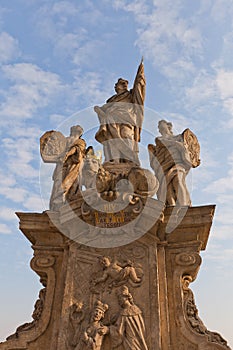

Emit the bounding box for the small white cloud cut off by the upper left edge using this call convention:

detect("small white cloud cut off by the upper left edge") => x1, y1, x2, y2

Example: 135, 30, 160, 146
0, 32, 20, 64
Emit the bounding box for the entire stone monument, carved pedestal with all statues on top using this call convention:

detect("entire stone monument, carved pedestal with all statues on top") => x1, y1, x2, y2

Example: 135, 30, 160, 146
0, 62, 230, 350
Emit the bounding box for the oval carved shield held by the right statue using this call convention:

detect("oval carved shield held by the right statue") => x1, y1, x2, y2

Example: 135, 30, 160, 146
182, 129, 201, 168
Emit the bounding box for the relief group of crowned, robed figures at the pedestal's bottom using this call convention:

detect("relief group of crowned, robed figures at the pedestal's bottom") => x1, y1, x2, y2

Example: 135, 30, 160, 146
69, 285, 148, 350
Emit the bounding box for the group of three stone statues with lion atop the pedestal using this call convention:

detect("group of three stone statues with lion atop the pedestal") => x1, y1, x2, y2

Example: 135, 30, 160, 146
40, 61, 200, 210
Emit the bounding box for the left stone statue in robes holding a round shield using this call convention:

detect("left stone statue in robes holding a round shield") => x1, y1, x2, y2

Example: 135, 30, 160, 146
40, 125, 86, 210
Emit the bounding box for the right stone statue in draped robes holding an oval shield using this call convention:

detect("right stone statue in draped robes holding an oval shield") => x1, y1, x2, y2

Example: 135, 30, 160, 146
148, 120, 200, 206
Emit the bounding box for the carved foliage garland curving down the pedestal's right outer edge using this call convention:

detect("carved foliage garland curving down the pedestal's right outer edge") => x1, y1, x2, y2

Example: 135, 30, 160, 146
182, 275, 230, 349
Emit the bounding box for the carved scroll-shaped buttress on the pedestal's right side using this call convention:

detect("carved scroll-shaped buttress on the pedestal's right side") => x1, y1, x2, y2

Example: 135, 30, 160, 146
166, 247, 230, 350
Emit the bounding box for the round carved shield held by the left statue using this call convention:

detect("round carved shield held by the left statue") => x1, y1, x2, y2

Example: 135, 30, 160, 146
40, 130, 66, 163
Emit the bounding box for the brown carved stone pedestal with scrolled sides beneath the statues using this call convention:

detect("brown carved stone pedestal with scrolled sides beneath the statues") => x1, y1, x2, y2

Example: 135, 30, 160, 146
0, 199, 229, 350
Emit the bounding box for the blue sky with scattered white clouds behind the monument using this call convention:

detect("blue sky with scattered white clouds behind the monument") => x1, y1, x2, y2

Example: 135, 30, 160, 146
0, 0, 233, 346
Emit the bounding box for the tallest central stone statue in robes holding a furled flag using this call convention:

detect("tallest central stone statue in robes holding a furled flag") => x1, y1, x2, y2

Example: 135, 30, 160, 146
94, 60, 146, 165
